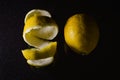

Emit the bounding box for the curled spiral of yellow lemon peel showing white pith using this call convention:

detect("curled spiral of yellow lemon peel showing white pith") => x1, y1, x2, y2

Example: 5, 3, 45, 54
22, 9, 58, 66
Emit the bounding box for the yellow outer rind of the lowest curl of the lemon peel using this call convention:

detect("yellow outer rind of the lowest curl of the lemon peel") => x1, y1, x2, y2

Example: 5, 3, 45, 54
22, 42, 57, 60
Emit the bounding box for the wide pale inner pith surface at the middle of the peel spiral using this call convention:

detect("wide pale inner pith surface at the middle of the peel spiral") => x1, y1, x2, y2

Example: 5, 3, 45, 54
23, 26, 58, 48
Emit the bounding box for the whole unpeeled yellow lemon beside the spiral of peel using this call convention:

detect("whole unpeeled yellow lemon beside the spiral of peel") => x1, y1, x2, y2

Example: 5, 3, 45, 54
64, 13, 99, 55
